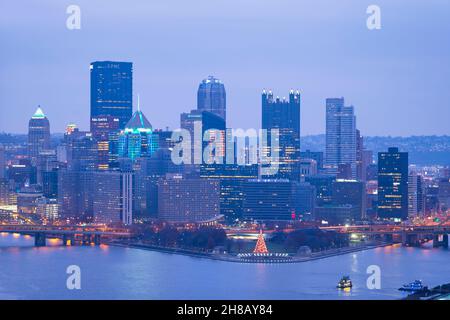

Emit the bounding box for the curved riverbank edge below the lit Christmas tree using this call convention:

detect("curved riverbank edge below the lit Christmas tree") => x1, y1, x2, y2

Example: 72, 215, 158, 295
106, 241, 394, 263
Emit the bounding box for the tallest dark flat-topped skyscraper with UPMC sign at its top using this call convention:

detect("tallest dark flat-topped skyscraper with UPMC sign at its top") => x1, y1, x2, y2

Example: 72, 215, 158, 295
90, 61, 133, 132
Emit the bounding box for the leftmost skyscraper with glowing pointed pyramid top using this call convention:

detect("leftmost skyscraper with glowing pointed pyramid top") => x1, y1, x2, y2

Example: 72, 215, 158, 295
28, 106, 50, 159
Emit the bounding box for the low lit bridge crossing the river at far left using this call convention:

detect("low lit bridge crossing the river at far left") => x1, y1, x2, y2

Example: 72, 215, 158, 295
0, 224, 131, 247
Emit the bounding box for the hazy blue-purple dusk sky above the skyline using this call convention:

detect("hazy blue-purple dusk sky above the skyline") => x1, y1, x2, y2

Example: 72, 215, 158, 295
0, 0, 450, 136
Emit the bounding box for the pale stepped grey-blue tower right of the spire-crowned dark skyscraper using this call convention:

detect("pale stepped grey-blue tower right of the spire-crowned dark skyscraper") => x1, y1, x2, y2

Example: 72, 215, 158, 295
325, 98, 356, 178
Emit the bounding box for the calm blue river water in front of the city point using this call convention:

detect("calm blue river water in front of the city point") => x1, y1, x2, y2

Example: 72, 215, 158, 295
0, 233, 450, 299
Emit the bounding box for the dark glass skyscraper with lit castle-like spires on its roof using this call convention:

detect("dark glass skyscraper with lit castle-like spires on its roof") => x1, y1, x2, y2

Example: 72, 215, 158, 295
262, 90, 300, 181
